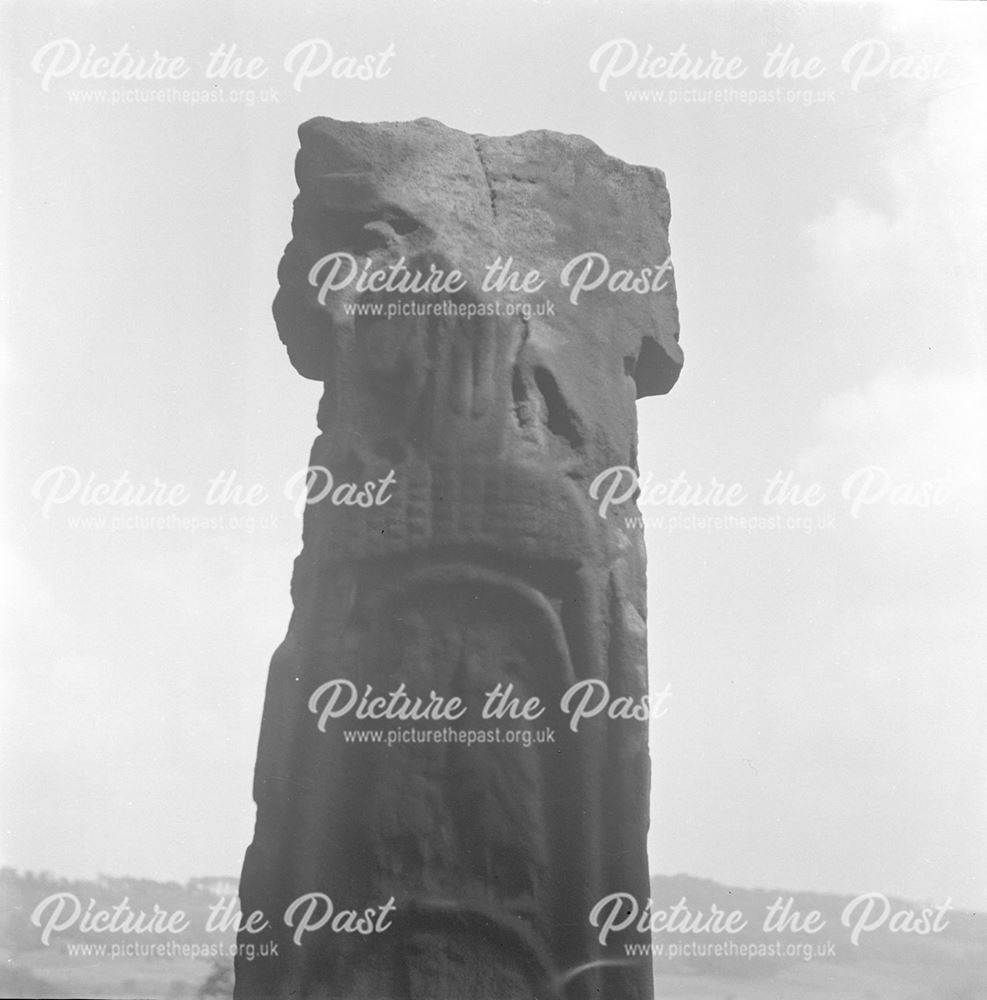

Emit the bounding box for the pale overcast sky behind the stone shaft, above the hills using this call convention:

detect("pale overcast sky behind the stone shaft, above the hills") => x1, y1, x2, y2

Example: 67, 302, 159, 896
0, 2, 987, 908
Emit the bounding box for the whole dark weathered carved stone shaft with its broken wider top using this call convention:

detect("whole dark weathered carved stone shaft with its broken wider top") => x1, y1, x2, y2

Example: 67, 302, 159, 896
237, 118, 681, 1000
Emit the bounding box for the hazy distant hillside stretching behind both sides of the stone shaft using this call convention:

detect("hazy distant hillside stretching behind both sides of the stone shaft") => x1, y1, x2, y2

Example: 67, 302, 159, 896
0, 868, 987, 1000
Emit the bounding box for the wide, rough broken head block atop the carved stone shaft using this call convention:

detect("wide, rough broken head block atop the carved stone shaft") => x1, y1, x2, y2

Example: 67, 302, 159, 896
275, 118, 682, 397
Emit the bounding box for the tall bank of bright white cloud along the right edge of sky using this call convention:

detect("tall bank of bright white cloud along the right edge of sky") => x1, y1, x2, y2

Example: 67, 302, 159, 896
796, 29, 987, 897
